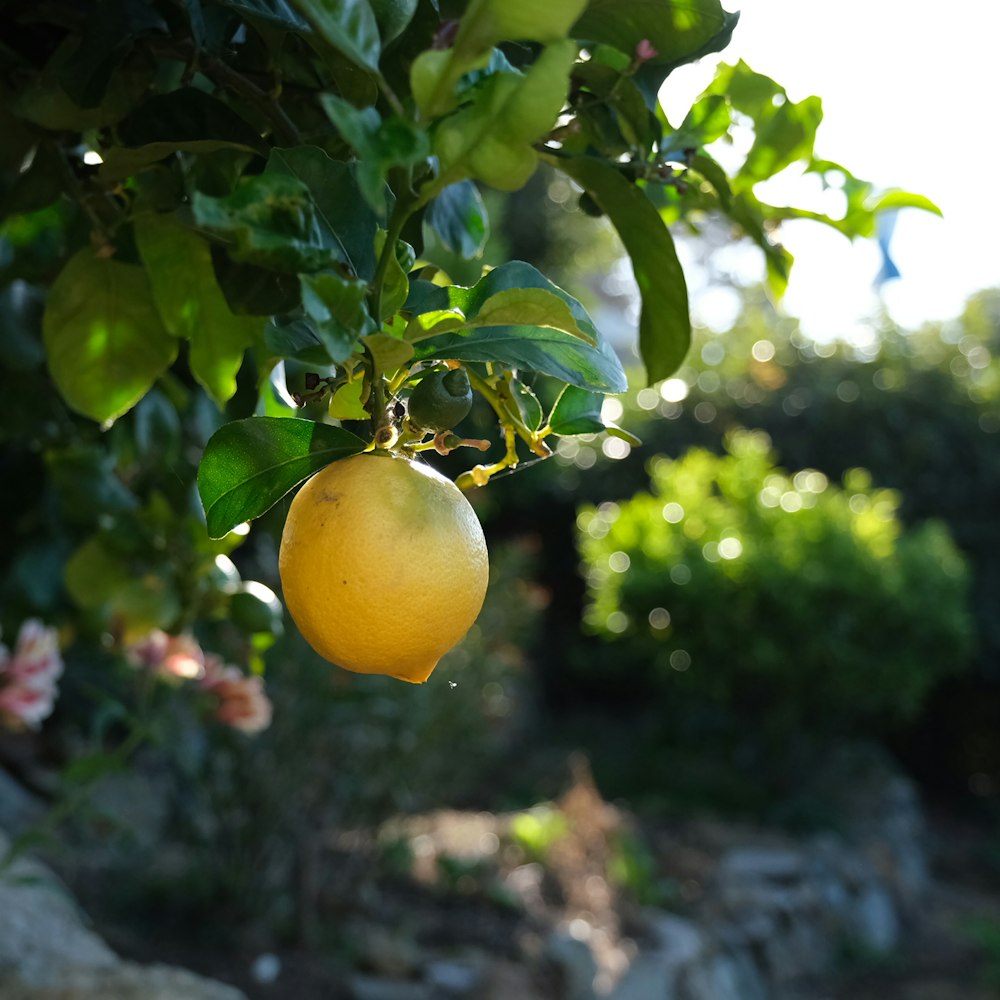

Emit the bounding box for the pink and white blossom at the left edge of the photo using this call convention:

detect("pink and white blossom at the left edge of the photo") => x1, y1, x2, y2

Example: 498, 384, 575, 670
0, 618, 63, 729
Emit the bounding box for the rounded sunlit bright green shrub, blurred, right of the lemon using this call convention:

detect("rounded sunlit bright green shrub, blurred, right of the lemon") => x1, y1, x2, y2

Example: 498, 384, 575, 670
578, 432, 972, 737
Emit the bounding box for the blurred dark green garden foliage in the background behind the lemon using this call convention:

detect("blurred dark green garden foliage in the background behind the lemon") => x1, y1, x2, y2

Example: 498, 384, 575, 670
0, 121, 1000, 964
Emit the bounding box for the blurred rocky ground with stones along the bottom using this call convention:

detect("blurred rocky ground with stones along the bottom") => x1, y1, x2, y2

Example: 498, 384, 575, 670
0, 752, 1000, 1000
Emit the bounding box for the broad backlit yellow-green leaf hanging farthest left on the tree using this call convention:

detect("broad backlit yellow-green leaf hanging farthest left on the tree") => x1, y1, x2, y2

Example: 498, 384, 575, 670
42, 249, 177, 421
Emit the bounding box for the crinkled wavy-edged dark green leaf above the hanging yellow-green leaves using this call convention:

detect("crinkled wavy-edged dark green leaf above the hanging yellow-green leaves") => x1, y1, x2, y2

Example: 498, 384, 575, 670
191, 172, 343, 272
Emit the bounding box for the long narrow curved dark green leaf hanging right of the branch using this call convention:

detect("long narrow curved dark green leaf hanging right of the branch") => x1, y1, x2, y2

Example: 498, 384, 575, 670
547, 156, 691, 391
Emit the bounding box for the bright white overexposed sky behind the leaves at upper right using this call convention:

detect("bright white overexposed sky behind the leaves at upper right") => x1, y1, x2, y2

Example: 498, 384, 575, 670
665, 0, 1000, 339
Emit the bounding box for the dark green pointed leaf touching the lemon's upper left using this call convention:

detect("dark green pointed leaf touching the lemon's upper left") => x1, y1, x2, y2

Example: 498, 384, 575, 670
198, 417, 365, 538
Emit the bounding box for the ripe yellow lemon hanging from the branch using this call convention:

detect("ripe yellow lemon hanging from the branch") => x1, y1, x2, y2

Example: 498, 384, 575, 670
278, 453, 489, 684
